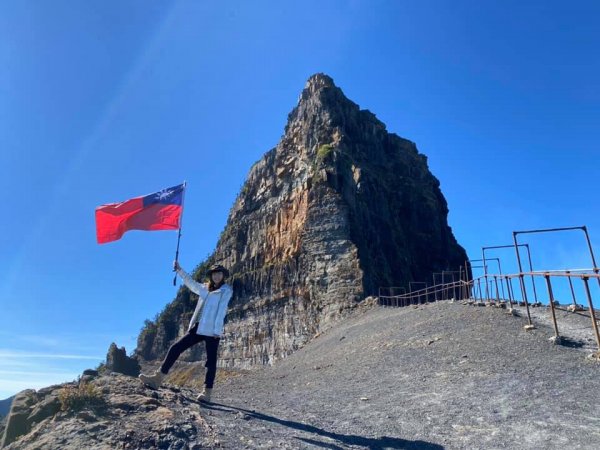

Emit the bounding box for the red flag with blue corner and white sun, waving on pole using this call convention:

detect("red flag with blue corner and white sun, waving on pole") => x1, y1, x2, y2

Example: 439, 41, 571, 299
96, 183, 185, 244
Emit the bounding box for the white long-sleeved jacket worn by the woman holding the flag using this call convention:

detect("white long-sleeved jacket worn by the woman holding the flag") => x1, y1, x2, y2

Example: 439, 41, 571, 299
177, 267, 233, 337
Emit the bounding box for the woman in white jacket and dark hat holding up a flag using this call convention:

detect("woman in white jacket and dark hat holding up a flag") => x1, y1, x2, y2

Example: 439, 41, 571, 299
140, 261, 233, 402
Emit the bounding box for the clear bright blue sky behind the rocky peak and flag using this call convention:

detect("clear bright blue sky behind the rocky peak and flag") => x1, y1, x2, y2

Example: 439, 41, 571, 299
0, 0, 600, 398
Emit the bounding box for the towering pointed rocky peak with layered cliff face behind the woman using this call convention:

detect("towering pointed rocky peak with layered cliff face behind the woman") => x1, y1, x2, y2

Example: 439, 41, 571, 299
136, 74, 466, 367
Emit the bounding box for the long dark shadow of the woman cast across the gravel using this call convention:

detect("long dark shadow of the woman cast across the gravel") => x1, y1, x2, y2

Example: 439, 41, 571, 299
202, 403, 444, 450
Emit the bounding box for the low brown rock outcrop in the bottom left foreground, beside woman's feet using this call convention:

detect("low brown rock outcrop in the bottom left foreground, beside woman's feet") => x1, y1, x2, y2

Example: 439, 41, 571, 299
0, 372, 219, 450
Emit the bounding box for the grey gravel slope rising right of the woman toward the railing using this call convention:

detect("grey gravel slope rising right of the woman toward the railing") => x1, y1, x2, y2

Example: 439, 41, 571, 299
202, 302, 600, 449
